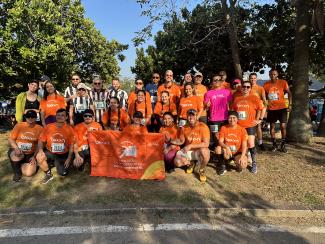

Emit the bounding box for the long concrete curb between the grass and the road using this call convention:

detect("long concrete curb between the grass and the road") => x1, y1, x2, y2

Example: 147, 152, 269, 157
0, 207, 325, 219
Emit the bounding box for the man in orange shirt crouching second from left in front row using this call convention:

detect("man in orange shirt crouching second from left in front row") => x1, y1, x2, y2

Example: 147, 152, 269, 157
36, 108, 75, 184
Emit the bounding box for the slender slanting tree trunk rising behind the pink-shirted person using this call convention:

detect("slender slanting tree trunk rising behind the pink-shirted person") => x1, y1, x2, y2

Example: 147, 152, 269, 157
221, 0, 243, 78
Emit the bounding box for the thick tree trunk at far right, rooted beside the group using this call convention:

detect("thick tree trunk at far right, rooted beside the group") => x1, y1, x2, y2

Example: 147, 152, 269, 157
287, 0, 313, 143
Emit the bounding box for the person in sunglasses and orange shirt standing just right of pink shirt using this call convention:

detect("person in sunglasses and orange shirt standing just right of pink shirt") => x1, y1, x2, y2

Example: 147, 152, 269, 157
232, 81, 263, 174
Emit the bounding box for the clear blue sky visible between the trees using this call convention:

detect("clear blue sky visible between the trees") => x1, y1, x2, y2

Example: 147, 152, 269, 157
82, 0, 273, 78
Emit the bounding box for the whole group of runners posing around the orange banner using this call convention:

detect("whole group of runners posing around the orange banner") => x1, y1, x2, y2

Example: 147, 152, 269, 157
8, 69, 291, 184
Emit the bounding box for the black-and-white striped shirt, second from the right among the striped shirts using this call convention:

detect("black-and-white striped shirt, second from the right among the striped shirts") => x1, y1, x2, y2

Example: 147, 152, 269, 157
89, 89, 109, 122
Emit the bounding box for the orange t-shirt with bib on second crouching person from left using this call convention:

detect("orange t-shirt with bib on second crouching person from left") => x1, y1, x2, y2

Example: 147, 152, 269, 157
39, 123, 75, 154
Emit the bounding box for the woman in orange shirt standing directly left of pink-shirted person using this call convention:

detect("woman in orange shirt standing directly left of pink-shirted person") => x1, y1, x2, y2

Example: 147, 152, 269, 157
178, 83, 203, 127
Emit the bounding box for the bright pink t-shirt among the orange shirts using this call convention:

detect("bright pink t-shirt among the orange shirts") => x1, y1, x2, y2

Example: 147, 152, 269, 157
204, 88, 232, 122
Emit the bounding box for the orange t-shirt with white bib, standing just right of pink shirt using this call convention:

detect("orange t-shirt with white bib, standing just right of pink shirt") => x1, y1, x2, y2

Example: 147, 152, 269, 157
232, 95, 263, 128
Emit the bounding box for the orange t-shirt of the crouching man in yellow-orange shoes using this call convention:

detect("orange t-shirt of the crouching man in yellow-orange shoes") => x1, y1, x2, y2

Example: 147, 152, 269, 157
180, 122, 210, 145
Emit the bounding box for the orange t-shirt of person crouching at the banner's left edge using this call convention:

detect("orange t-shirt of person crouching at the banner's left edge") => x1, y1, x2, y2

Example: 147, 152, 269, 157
73, 121, 102, 151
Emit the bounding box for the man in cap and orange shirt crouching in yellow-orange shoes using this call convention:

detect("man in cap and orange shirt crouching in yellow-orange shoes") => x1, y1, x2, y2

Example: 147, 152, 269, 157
167, 109, 210, 182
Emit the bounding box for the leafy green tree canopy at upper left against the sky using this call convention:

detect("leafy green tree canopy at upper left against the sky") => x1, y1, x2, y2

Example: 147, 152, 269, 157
0, 0, 128, 95
